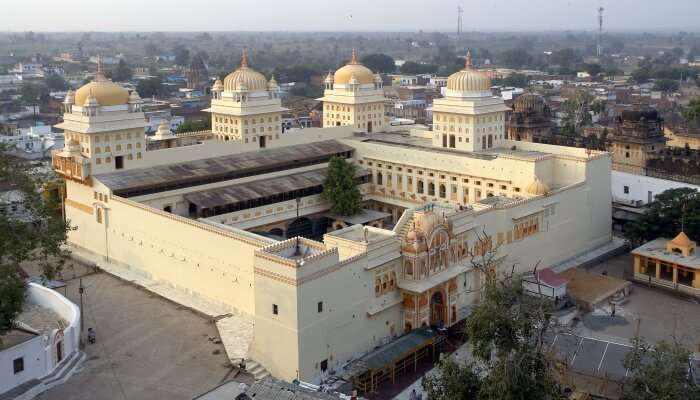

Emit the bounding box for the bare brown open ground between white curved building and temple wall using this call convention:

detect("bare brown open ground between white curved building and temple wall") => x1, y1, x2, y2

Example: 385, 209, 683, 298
26, 262, 243, 400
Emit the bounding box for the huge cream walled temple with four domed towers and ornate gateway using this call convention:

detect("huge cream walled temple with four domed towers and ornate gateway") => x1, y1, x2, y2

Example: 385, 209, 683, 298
52, 54, 611, 382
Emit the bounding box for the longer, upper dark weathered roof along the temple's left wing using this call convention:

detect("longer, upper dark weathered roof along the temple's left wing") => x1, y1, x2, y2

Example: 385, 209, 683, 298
95, 140, 353, 197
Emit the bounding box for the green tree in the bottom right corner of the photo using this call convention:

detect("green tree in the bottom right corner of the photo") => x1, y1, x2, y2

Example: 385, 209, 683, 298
622, 338, 700, 400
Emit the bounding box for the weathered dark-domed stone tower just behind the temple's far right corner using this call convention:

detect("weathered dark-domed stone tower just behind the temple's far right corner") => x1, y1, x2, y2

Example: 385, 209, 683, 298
610, 106, 667, 175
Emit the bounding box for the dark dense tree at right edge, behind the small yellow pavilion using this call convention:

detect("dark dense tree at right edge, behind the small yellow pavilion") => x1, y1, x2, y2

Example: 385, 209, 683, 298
624, 188, 700, 244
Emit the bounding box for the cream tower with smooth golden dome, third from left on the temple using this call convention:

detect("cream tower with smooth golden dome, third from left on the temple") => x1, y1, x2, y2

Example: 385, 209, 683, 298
319, 49, 388, 133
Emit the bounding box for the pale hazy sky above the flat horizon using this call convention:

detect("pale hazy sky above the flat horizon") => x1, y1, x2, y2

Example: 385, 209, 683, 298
5, 0, 700, 31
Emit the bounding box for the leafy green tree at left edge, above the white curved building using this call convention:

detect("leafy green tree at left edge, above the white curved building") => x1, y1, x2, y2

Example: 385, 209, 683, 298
0, 147, 69, 336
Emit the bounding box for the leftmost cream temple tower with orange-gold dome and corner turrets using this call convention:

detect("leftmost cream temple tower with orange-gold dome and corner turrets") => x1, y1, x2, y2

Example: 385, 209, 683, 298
52, 57, 146, 184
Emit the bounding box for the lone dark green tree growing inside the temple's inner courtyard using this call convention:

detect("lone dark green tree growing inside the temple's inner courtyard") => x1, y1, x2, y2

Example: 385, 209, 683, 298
322, 157, 362, 216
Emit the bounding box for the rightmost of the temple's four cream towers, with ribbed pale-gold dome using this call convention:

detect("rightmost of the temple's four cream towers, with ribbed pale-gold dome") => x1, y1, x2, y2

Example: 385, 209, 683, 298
433, 51, 508, 151
